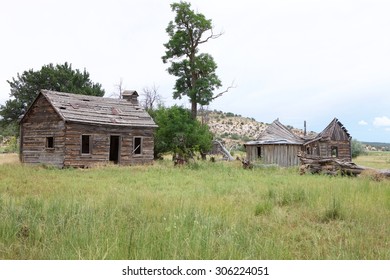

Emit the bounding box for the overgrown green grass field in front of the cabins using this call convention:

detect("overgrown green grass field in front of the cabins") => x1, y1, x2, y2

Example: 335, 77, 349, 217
0, 154, 390, 260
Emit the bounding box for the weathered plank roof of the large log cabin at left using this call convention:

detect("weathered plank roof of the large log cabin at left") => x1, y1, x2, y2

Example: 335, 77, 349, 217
32, 90, 157, 127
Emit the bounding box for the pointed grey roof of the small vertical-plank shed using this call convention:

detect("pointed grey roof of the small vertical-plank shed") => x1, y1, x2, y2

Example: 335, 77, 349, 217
246, 120, 304, 145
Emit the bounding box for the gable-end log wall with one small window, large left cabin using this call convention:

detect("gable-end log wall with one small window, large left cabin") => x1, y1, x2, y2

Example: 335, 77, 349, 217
20, 96, 65, 167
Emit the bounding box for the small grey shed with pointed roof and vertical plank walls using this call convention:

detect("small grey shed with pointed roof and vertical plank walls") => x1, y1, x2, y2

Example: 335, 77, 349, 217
244, 120, 304, 166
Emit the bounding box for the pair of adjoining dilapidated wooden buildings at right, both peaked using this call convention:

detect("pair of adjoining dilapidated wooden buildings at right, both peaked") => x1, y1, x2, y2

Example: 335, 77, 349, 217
244, 118, 352, 166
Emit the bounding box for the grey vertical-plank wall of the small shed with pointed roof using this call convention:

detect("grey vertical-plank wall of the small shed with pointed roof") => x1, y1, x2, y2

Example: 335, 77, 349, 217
246, 144, 302, 167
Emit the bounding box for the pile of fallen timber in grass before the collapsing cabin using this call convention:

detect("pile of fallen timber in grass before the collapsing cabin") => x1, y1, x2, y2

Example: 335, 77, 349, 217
298, 154, 390, 178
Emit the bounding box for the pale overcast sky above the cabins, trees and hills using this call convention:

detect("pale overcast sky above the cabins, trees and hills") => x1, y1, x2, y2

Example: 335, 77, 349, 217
0, 0, 390, 142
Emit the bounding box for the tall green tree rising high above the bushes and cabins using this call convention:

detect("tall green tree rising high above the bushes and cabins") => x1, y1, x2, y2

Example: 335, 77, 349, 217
162, 2, 227, 119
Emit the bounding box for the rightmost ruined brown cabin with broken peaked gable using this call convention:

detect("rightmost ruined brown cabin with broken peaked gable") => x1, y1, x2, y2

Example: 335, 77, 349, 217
304, 118, 352, 161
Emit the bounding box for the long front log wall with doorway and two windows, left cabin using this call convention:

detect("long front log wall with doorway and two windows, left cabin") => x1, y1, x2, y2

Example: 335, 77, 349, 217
64, 123, 154, 167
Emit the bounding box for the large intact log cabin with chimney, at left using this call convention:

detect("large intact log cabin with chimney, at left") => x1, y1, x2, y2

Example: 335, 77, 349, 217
20, 90, 157, 168
